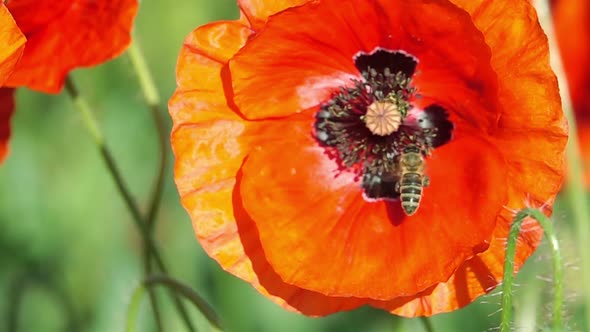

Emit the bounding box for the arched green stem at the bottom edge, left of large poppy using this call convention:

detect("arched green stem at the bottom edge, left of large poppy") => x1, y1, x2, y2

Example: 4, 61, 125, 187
126, 276, 223, 332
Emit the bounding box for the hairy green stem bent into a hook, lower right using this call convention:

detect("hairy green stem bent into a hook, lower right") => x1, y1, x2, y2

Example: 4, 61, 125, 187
500, 208, 563, 332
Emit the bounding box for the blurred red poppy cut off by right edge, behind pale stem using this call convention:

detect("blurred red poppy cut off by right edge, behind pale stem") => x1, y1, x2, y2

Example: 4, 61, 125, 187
553, 0, 590, 184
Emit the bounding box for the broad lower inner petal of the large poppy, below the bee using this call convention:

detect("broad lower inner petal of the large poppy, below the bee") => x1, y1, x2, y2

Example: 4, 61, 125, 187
241, 122, 506, 299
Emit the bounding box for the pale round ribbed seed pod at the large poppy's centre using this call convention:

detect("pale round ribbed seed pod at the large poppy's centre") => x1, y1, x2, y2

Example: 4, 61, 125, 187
363, 101, 402, 136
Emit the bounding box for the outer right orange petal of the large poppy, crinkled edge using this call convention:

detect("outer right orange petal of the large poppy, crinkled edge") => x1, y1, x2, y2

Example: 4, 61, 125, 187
372, 0, 567, 317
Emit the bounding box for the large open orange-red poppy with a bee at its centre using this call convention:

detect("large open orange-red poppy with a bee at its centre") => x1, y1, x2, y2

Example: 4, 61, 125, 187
169, 0, 566, 316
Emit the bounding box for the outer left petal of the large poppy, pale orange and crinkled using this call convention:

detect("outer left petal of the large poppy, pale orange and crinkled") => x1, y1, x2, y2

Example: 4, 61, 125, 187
169, 22, 366, 316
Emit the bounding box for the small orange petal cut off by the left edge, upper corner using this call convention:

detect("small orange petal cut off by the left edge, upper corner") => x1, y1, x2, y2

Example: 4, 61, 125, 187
0, 2, 26, 86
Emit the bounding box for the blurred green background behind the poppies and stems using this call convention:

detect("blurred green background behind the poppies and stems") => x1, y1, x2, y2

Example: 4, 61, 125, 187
0, 0, 587, 332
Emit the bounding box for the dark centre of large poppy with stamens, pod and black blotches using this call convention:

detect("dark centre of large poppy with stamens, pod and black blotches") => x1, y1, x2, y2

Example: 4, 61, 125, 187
315, 49, 453, 199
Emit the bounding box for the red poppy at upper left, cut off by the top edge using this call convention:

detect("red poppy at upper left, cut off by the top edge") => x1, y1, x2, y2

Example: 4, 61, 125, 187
6, 0, 138, 93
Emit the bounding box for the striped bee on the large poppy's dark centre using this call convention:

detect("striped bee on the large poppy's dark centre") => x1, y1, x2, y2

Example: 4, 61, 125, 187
395, 144, 430, 216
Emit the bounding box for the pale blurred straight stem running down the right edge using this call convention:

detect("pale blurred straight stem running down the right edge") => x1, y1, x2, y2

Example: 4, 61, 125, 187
536, 0, 590, 327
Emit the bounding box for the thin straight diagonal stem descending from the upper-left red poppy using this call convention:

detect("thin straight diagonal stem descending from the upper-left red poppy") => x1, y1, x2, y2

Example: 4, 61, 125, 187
65, 77, 195, 331
